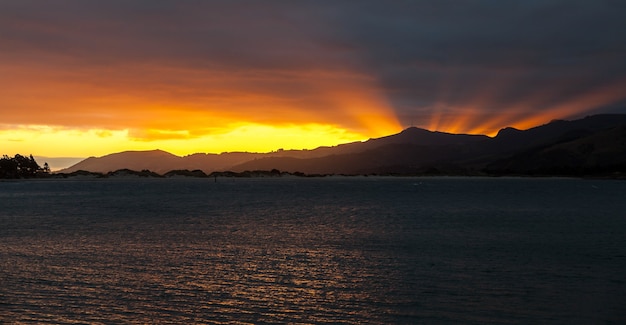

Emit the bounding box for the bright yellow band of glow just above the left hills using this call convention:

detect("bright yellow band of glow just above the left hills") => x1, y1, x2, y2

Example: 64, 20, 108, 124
0, 124, 368, 157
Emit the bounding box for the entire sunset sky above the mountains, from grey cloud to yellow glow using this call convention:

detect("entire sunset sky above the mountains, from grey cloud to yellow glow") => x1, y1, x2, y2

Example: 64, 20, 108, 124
0, 0, 626, 157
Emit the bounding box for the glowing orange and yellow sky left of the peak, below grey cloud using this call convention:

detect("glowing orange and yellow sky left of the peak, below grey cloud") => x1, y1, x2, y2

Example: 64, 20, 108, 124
0, 63, 402, 156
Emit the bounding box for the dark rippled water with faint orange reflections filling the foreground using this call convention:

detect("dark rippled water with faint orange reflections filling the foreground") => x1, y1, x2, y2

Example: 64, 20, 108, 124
0, 177, 626, 324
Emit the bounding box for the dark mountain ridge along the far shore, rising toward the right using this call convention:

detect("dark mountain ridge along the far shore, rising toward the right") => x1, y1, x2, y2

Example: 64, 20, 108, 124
61, 114, 626, 175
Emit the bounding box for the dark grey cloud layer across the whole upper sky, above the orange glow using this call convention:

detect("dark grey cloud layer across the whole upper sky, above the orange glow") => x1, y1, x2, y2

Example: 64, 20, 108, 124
0, 0, 626, 132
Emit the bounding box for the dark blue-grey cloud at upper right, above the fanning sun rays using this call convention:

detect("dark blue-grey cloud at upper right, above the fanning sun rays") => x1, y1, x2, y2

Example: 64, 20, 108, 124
322, 1, 626, 121
